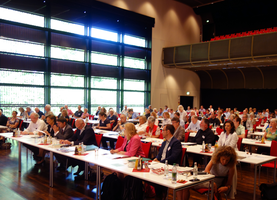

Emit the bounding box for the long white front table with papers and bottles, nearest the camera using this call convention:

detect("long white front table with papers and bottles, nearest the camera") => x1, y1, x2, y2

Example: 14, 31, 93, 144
0, 133, 214, 199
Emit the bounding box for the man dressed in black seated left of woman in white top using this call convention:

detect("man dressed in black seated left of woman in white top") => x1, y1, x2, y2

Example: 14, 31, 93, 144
192, 119, 215, 145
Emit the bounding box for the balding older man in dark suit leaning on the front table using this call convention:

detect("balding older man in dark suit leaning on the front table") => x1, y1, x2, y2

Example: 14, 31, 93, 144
55, 119, 97, 175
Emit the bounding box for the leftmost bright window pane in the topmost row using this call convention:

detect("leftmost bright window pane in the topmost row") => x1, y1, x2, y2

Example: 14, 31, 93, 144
0, 7, 44, 27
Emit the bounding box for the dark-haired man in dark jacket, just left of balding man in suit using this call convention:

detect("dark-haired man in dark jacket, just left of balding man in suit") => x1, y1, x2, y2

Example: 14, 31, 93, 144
54, 117, 74, 140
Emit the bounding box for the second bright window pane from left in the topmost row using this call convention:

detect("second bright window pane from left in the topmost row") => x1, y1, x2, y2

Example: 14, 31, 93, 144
51, 19, 85, 35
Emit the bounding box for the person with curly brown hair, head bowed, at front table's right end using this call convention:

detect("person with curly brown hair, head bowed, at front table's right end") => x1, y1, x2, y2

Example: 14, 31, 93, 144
182, 146, 237, 200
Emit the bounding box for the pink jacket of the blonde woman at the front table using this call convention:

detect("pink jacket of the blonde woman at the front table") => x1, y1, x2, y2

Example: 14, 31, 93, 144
117, 135, 145, 157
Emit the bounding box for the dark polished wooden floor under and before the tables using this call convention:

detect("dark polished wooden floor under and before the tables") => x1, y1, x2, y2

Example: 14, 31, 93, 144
0, 141, 273, 200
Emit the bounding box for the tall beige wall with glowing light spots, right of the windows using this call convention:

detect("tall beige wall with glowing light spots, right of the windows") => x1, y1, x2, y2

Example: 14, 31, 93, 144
99, 0, 201, 109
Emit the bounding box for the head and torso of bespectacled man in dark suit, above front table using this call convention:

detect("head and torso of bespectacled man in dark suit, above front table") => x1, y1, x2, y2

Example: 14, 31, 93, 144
154, 124, 182, 165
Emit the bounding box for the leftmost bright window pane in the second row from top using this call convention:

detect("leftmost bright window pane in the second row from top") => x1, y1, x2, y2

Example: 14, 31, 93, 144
0, 36, 44, 57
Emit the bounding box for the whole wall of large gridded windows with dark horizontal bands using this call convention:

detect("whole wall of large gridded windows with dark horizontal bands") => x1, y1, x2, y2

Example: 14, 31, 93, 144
0, 4, 151, 116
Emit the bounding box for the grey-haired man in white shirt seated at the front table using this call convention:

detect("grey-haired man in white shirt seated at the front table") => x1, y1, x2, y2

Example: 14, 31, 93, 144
21, 112, 47, 160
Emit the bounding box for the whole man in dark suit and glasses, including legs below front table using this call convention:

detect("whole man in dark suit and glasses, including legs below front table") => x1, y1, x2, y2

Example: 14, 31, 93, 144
152, 124, 182, 200
